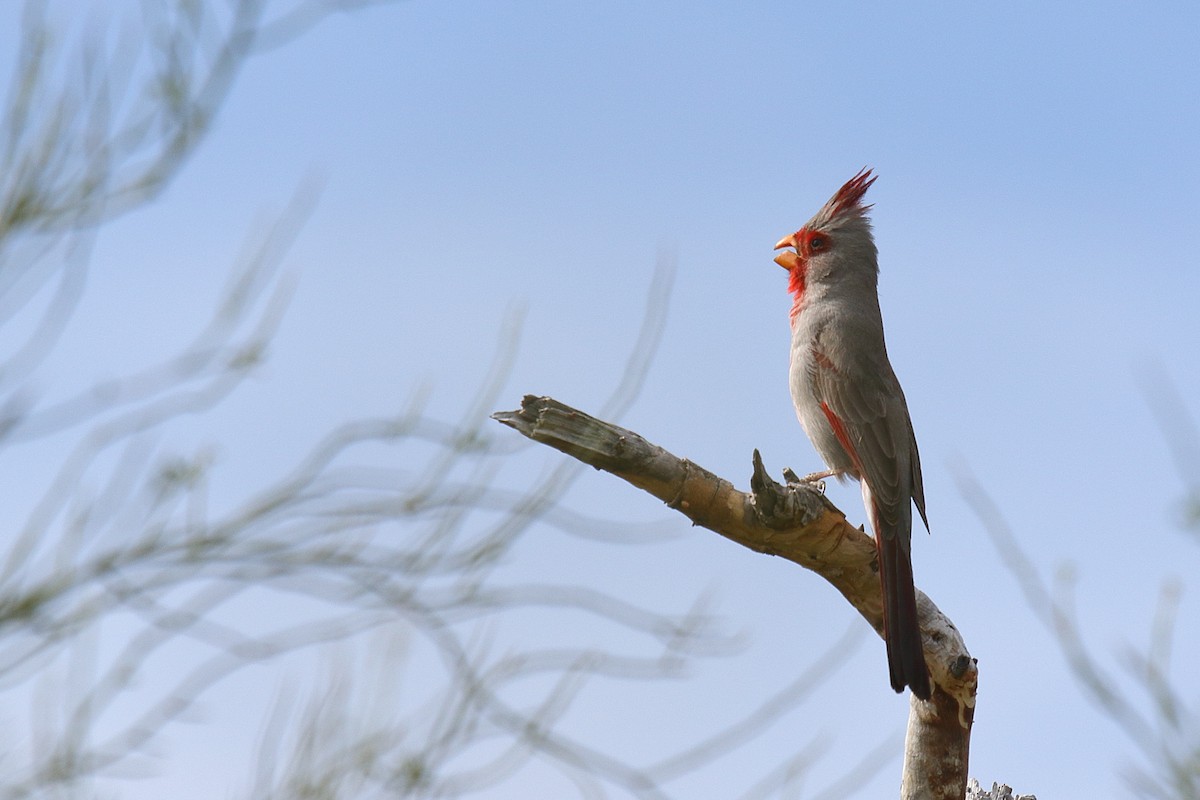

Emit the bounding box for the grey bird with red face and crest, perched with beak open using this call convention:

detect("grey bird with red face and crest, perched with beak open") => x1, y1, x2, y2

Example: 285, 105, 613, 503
775, 168, 930, 700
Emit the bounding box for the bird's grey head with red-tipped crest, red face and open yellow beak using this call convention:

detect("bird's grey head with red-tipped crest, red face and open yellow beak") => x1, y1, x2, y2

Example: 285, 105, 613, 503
775, 169, 878, 303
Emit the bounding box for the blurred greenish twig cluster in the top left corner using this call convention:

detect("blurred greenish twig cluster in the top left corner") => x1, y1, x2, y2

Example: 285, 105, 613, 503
0, 0, 384, 243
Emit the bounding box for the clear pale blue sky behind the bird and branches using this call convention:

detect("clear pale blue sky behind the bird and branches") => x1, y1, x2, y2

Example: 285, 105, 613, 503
0, 1, 1200, 798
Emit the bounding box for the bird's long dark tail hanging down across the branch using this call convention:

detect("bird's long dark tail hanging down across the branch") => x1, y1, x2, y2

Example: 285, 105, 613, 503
875, 530, 930, 700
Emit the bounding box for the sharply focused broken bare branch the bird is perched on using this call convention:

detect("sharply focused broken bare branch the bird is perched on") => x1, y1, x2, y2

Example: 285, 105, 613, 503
492, 395, 978, 800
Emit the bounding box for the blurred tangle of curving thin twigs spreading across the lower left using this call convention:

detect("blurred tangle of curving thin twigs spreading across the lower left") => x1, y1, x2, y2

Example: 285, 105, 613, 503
0, 230, 859, 798
